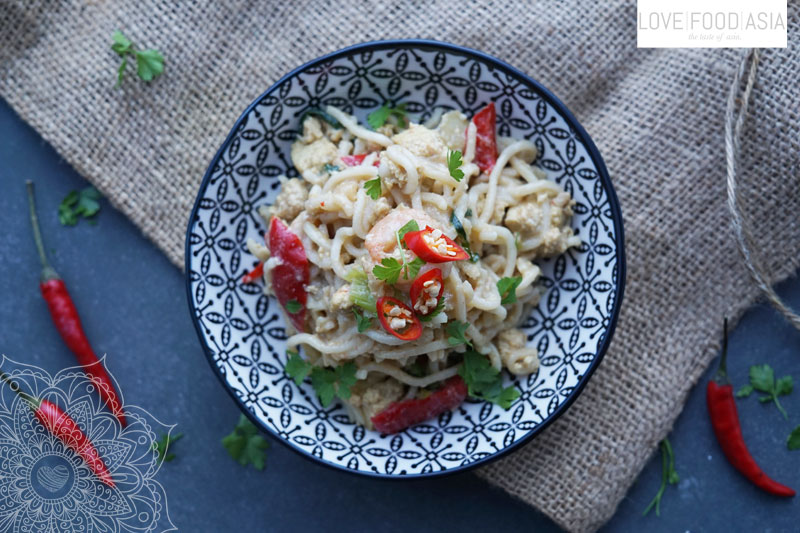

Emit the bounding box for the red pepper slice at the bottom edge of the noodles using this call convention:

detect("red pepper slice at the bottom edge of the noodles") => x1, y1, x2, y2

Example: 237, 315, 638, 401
370, 376, 467, 433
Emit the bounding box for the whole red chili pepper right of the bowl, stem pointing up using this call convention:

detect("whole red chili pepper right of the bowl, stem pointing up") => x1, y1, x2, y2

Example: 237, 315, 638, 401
706, 319, 795, 497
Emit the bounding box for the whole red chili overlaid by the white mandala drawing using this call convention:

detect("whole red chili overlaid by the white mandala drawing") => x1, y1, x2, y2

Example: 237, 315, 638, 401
0, 372, 114, 487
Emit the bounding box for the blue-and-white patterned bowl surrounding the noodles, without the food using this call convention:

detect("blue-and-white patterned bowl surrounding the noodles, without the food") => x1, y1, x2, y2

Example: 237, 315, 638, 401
186, 41, 625, 477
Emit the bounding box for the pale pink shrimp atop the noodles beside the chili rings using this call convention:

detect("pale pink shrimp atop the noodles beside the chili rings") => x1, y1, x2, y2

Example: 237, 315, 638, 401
364, 205, 450, 286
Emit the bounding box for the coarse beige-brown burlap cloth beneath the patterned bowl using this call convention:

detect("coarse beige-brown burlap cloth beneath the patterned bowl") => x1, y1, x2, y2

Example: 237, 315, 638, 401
0, 0, 800, 531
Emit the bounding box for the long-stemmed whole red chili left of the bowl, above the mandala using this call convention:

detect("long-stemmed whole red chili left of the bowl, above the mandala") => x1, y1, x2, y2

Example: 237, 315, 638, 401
26, 181, 127, 427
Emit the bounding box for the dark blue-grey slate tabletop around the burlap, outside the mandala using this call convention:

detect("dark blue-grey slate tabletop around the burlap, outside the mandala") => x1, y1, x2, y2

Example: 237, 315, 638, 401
0, 101, 800, 532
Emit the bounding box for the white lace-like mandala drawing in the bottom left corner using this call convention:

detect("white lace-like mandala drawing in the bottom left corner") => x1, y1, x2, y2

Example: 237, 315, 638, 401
0, 356, 176, 533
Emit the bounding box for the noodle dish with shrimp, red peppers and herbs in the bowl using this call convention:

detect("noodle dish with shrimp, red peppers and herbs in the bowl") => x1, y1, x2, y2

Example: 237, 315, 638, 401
244, 104, 580, 433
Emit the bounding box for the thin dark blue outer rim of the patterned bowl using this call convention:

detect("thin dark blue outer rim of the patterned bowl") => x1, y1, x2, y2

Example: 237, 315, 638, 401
184, 39, 626, 479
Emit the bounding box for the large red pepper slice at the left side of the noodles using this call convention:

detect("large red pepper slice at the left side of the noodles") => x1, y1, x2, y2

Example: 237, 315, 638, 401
268, 217, 311, 331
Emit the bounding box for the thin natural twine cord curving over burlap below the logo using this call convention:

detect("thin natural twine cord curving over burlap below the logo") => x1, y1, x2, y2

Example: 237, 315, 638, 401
725, 48, 800, 329
